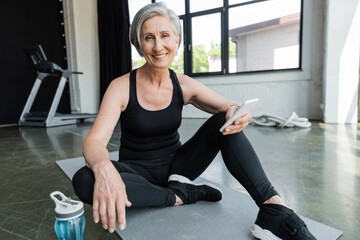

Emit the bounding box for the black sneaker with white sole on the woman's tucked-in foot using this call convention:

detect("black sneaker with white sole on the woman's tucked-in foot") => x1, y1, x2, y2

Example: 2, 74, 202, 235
168, 174, 222, 204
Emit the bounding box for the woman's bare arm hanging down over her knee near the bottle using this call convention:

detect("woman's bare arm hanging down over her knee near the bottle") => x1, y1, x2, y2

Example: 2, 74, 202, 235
83, 75, 131, 232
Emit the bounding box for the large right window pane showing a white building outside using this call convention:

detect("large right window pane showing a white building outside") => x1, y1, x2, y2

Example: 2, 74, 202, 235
228, 0, 300, 72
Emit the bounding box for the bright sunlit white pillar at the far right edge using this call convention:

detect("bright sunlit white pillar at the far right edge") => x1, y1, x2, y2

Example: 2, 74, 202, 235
324, 0, 360, 123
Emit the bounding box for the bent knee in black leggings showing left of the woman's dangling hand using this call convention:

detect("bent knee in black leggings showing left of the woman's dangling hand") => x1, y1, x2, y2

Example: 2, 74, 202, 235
72, 166, 95, 204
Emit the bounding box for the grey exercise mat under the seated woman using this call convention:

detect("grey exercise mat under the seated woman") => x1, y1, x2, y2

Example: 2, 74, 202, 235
57, 155, 343, 240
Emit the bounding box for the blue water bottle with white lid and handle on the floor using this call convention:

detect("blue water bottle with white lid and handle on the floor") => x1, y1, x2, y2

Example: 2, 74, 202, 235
50, 191, 85, 240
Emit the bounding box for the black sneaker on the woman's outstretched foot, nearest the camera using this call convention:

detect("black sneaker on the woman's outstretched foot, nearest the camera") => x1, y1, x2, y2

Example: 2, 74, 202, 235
251, 204, 316, 240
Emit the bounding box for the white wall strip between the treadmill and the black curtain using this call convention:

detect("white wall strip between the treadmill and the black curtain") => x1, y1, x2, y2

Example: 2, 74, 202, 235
63, 0, 100, 113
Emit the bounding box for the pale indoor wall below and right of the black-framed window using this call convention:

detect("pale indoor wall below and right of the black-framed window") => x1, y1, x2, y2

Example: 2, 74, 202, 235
184, 0, 324, 119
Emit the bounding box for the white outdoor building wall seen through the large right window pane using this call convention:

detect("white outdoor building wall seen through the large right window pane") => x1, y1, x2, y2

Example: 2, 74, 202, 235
232, 22, 300, 72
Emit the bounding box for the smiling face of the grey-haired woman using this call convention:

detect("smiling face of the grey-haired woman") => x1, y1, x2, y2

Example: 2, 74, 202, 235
140, 16, 179, 68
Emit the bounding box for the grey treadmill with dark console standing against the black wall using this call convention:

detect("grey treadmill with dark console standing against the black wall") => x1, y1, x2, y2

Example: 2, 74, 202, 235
19, 45, 97, 127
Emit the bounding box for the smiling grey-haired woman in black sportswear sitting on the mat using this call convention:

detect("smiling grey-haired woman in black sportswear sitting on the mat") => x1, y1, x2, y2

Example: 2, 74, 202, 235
73, 3, 315, 239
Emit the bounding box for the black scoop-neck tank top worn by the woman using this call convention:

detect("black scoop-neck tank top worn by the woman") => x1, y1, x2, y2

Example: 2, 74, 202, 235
119, 69, 184, 160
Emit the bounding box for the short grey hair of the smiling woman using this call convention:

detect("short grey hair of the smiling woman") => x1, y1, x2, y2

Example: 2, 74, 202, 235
129, 2, 182, 57
